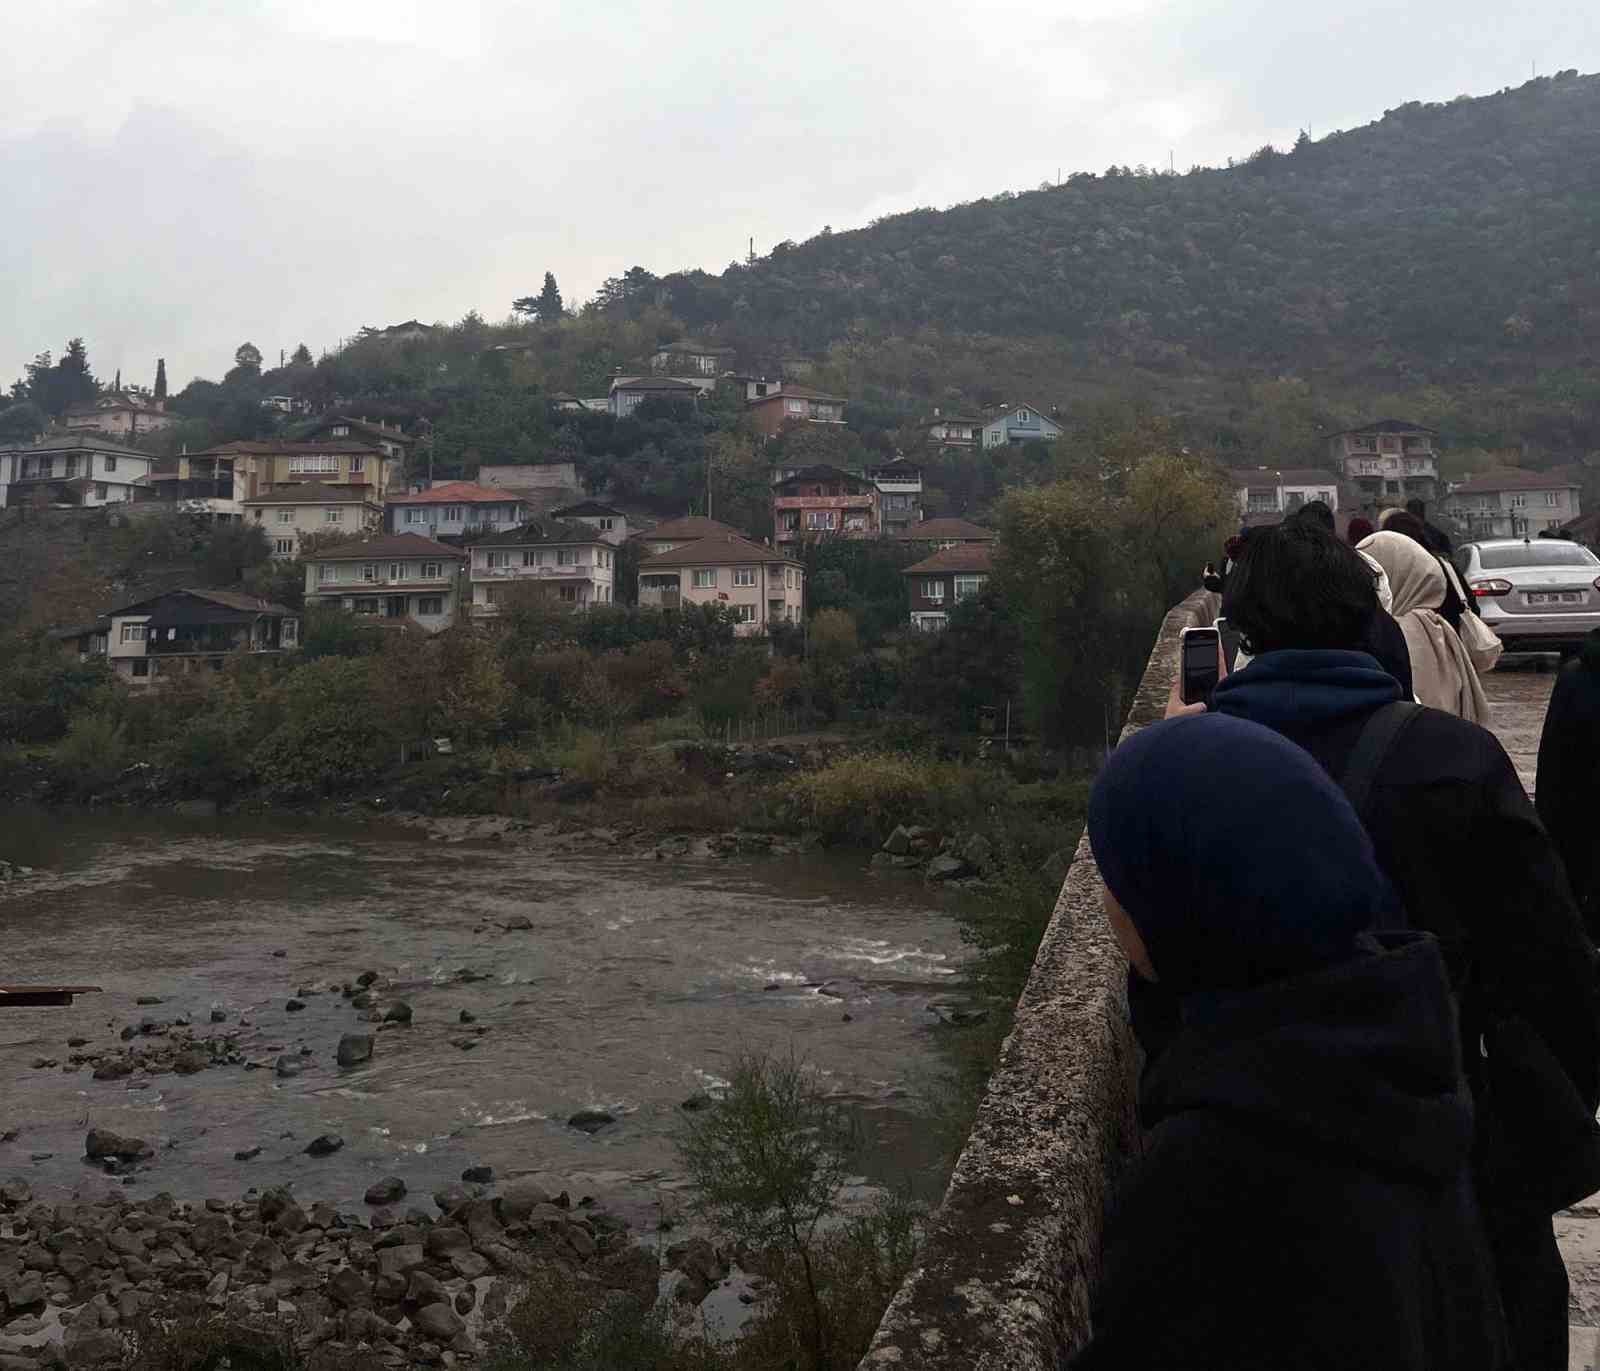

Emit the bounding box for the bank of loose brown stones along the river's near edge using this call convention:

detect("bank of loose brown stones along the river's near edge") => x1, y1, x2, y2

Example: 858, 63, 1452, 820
0, 1151, 728, 1371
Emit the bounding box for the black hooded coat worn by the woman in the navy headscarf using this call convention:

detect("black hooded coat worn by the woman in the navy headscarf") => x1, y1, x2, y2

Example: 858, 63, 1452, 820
1074, 934, 1507, 1371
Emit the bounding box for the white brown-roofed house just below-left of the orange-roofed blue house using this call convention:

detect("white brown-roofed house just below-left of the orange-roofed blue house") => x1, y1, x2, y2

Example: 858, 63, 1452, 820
306, 533, 467, 634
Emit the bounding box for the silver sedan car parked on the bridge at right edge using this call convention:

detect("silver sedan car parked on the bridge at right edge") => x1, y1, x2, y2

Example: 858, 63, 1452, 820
1454, 538, 1600, 653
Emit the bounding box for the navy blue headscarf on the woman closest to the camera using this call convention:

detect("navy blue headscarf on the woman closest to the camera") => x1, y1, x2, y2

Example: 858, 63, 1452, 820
1088, 713, 1403, 995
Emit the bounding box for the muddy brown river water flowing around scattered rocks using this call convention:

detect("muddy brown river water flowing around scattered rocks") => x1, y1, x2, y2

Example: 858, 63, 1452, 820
0, 813, 962, 1216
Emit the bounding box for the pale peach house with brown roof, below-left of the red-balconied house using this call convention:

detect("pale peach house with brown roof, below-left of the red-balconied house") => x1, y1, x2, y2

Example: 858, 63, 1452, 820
638, 533, 805, 637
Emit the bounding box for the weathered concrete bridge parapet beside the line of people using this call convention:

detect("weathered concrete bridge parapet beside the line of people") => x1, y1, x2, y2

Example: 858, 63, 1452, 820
861, 590, 1216, 1371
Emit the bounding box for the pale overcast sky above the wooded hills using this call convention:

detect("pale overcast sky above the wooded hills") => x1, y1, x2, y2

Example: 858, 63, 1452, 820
0, 0, 1600, 389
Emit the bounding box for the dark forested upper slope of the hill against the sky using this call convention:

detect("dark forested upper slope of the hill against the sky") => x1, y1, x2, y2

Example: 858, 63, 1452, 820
662, 72, 1600, 379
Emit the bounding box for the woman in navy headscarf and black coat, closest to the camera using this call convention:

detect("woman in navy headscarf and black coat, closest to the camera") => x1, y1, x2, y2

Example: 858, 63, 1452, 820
1074, 715, 1512, 1371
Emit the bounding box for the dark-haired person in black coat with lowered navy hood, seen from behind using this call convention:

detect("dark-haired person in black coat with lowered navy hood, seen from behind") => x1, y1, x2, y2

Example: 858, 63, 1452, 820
1203, 522, 1600, 1371
